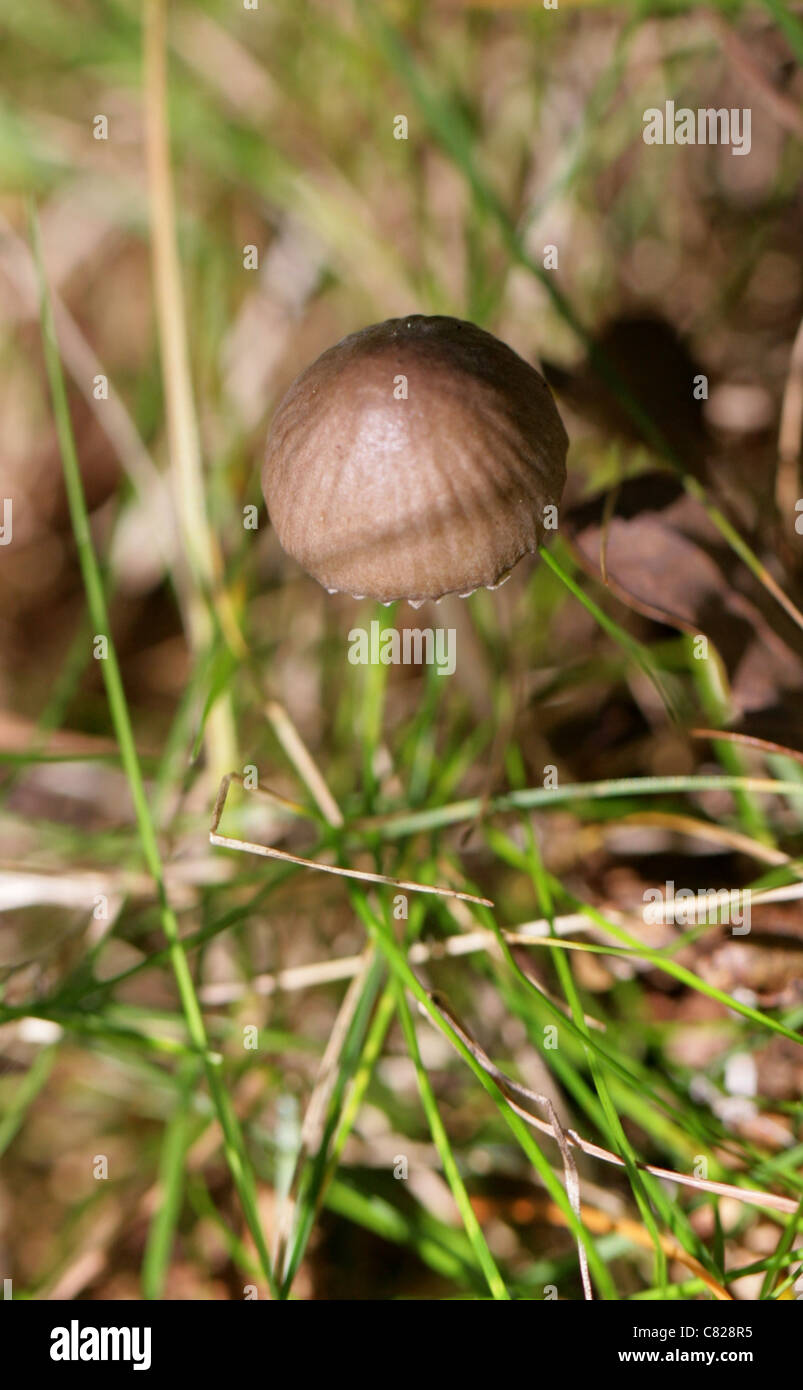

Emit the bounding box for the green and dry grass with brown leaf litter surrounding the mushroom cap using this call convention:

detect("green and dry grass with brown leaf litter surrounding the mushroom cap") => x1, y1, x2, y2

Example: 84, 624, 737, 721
0, 0, 803, 1300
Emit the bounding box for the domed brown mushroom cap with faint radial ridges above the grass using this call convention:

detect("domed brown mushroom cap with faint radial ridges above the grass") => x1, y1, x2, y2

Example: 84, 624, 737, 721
263, 314, 568, 603
